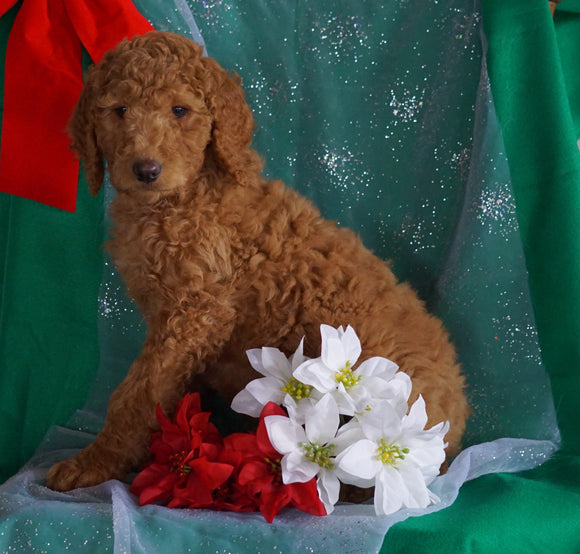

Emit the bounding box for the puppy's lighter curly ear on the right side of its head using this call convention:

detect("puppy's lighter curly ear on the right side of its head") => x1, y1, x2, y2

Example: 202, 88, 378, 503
201, 58, 262, 182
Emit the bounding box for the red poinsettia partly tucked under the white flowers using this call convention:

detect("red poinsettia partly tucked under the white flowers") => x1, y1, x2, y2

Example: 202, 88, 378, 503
234, 402, 326, 523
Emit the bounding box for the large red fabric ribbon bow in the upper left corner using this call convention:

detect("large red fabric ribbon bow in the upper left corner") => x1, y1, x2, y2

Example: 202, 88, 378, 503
0, 0, 153, 212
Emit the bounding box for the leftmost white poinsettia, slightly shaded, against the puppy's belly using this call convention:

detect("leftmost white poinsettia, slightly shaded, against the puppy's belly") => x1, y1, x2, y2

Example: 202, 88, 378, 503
232, 339, 319, 417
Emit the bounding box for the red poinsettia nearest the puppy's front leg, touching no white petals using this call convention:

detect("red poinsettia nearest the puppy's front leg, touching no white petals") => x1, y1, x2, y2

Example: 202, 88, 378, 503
131, 393, 233, 508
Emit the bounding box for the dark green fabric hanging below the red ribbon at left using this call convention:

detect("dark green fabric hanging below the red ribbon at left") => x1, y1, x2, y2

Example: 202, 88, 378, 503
0, 6, 103, 482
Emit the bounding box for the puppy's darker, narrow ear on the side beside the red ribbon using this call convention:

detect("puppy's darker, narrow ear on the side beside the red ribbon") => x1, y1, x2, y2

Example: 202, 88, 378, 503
67, 74, 105, 196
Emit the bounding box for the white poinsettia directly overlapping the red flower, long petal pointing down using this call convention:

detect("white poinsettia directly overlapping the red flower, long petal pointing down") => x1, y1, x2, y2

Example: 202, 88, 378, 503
264, 395, 340, 514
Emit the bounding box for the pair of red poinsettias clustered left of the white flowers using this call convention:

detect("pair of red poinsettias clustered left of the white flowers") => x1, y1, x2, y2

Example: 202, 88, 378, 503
131, 393, 326, 523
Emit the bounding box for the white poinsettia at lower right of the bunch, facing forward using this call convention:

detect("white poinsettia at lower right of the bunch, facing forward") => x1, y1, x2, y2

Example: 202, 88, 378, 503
336, 396, 449, 515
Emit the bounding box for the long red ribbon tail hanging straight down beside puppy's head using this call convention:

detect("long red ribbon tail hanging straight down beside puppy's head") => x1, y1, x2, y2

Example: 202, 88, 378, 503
0, 0, 82, 211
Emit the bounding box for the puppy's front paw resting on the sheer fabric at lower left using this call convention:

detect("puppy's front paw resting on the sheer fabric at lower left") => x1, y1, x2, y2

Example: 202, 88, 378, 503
46, 452, 122, 492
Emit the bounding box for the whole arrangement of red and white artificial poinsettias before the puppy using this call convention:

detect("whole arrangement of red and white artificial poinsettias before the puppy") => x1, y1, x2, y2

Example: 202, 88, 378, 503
131, 325, 449, 523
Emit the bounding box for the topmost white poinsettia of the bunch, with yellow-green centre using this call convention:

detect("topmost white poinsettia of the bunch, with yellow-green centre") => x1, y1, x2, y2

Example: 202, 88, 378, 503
294, 325, 404, 416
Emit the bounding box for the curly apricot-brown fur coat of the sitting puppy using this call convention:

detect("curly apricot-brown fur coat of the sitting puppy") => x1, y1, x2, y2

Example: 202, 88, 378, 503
47, 32, 468, 490
